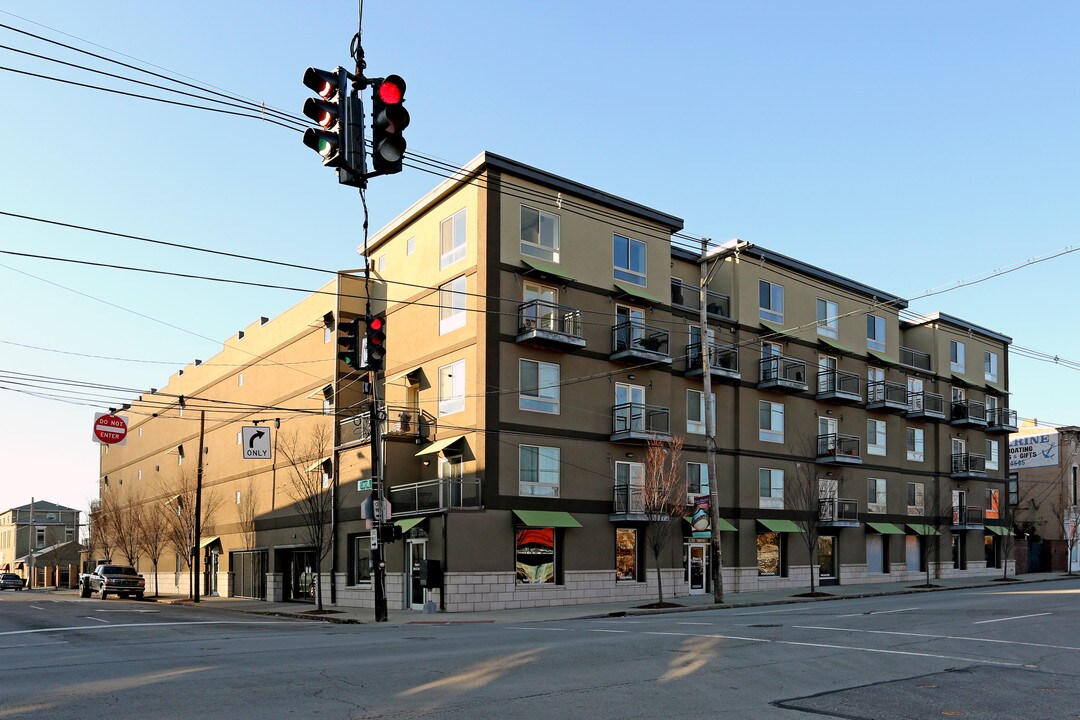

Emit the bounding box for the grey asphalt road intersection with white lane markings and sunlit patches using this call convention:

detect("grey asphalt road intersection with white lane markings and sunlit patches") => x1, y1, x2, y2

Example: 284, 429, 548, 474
0, 580, 1080, 720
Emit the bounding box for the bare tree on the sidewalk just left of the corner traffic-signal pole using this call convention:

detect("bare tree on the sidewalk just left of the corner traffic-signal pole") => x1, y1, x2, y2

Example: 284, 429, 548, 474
278, 423, 338, 611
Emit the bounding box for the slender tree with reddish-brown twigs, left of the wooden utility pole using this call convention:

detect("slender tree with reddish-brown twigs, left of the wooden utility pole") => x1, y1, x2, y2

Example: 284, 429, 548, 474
642, 435, 687, 606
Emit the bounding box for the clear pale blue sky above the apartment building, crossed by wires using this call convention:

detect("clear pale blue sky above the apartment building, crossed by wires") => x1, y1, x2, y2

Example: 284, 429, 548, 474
0, 0, 1080, 508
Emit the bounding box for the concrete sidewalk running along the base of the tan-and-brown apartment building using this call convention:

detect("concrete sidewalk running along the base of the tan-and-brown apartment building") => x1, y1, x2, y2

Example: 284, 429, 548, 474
116, 572, 1080, 625
